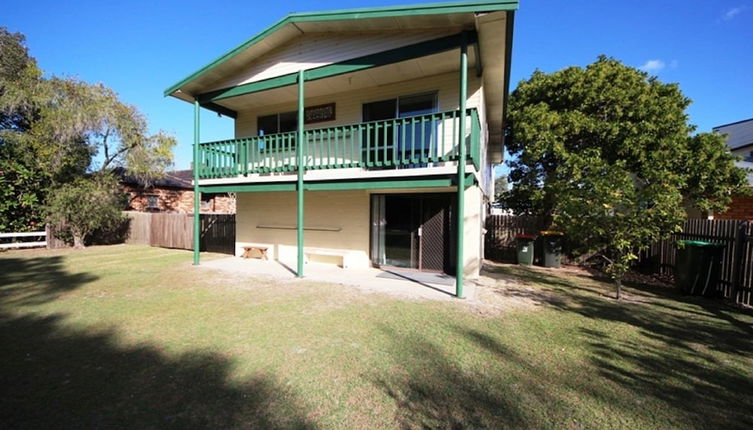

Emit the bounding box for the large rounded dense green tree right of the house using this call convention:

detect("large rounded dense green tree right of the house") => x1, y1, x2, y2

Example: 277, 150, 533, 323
504, 56, 746, 298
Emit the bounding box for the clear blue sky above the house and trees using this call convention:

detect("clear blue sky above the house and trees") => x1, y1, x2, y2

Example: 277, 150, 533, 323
5, 0, 753, 168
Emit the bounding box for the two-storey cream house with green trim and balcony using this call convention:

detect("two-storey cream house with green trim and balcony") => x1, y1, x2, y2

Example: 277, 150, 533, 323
165, 0, 518, 297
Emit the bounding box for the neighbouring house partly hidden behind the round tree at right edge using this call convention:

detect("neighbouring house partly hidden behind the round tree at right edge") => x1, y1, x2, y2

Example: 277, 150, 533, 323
713, 118, 753, 220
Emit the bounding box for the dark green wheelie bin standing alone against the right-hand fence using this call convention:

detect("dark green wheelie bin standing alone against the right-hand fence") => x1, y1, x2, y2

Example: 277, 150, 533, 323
675, 240, 725, 297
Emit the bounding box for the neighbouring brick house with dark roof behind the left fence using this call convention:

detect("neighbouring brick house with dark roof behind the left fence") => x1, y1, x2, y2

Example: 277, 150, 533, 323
116, 170, 235, 214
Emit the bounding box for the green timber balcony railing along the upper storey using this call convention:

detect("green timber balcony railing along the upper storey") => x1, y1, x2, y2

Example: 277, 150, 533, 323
197, 109, 481, 179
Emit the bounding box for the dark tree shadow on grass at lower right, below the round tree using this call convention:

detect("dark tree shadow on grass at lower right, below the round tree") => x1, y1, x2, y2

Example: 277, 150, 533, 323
484, 267, 753, 428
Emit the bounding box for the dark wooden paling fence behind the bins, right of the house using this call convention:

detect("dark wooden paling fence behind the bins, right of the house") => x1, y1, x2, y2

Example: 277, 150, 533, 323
485, 215, 753, 305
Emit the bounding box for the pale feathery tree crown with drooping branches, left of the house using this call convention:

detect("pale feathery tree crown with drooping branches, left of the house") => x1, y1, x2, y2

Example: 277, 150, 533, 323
26, 78, 175, 180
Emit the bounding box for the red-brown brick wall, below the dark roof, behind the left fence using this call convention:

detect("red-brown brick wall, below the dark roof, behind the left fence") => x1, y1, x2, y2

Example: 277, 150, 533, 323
121, 184, 235, 214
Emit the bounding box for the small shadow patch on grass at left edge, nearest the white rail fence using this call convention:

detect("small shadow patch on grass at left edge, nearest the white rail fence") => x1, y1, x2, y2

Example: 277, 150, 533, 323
0, 256, 98, 306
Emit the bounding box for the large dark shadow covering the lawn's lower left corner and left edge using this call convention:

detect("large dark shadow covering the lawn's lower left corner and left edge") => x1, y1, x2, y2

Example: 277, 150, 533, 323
0, 256, 315, 429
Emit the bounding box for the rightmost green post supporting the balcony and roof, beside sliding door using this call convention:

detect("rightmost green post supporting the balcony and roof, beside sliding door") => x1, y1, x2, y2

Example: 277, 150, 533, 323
455, 32, 468, 299
